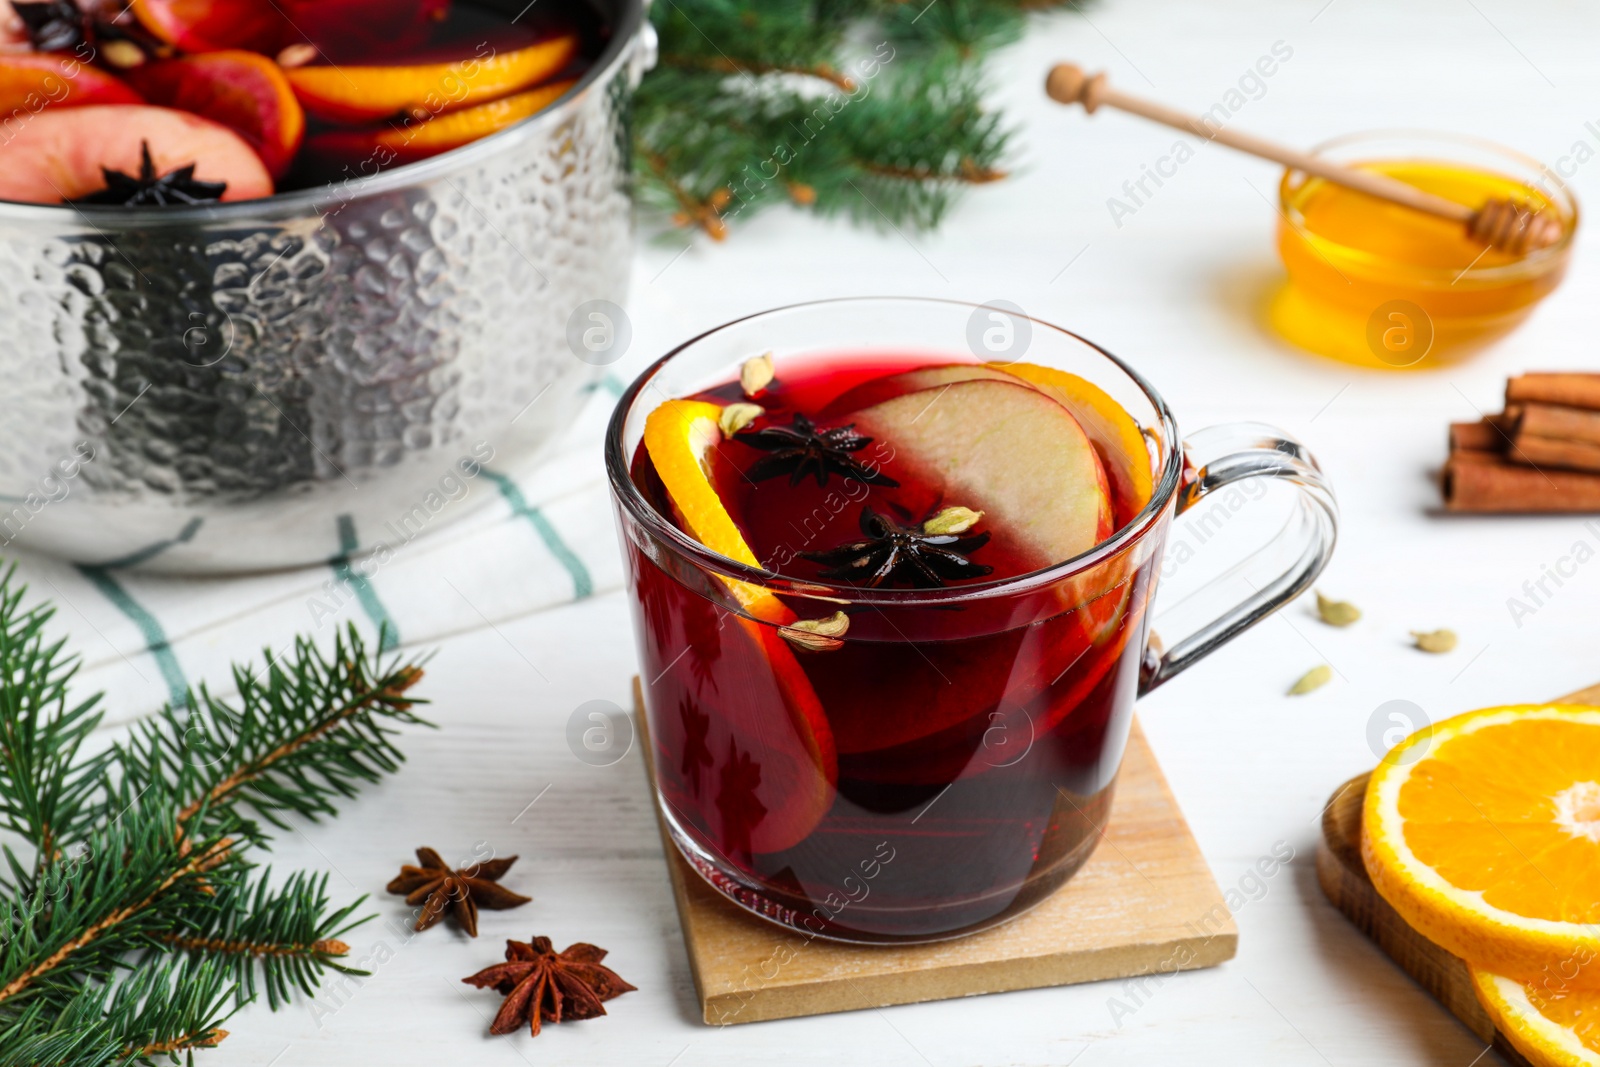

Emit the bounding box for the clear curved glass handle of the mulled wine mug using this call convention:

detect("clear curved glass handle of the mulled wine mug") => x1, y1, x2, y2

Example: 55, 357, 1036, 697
1139, 422, 1339, 696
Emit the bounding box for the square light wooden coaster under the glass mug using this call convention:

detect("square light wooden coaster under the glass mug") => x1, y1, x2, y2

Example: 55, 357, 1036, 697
634, 680, 1238, 1025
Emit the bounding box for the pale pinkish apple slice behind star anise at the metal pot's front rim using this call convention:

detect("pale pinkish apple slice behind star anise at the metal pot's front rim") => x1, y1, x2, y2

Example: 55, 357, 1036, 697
0, 104, 272, 203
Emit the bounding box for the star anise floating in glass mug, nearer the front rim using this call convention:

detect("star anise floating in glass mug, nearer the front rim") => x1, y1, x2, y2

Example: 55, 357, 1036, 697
800, 507, 994, 589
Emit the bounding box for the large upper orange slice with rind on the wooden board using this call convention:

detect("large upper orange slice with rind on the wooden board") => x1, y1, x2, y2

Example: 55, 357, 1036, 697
1362, 704, 1600, 989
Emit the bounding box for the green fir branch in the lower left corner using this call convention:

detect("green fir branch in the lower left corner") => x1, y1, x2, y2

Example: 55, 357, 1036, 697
0, 571, 426, 1067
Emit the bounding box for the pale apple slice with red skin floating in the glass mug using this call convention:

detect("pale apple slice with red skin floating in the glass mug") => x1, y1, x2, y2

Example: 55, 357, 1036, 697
853, 379, 1112, 566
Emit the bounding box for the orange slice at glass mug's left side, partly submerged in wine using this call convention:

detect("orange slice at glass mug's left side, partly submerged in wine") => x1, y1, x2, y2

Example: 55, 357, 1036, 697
645, 400, 838, 853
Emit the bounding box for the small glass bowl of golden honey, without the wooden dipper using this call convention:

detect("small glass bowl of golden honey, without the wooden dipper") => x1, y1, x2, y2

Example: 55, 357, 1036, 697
1267, 131, 1578, 370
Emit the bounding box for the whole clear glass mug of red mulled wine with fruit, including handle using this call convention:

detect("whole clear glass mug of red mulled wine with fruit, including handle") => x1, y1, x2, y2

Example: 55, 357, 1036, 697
606, 299, 1336, 942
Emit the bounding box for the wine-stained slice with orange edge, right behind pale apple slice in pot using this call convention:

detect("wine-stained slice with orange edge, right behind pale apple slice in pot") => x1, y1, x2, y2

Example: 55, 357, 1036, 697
128, 50, 306, 178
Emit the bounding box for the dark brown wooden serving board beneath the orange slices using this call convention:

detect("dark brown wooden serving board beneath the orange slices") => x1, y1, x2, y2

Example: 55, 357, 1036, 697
1317, 686, 1600, 1067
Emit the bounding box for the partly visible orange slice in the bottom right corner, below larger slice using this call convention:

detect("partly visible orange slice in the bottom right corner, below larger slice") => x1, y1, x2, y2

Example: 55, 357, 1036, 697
1467, 966, 1600, 1067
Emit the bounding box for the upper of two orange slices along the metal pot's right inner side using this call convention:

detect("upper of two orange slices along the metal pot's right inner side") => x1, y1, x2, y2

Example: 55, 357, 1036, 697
285, 34, 578, 125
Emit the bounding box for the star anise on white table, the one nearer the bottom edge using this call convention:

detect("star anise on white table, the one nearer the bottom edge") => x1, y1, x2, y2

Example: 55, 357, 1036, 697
461, 937, 635, 1037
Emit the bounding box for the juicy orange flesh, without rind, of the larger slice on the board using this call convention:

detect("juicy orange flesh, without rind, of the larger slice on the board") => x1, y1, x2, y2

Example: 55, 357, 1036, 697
1398, 720, 1600, 923
